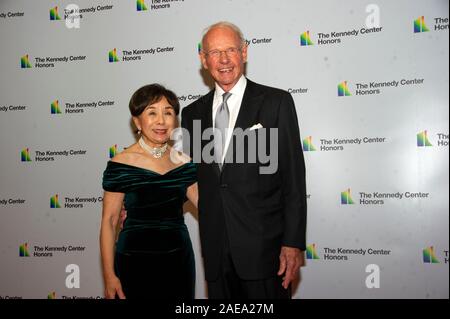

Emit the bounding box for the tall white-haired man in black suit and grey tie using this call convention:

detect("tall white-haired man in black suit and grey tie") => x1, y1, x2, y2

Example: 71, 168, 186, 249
182, 22, 306, 299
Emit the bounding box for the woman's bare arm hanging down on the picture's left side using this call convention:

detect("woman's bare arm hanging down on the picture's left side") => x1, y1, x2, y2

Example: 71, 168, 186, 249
100, 191, 125, 299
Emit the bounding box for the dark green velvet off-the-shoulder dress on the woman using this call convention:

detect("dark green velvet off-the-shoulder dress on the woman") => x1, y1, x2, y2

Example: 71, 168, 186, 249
103, 161, 197, 299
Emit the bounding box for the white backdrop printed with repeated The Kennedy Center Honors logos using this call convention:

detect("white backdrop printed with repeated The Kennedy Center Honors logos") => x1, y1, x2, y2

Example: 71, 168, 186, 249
0, 0, 449, 298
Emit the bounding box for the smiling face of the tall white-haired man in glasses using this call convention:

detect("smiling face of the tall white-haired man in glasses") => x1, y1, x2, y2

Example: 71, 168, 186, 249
200, 27, 247, 92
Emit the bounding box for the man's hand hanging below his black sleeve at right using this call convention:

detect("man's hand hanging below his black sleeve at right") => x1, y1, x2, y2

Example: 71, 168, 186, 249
278, 246, 305, 289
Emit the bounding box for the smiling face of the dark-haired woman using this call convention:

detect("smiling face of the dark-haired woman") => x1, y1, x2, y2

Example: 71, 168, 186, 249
133, 96, 177, 147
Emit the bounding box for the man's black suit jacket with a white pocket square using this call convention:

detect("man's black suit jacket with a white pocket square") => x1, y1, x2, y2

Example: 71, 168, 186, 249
182, 80, 306, 281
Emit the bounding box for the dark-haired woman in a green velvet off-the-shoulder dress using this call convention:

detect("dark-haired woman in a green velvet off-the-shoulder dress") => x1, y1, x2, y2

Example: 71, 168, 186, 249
100, 84, 198, 299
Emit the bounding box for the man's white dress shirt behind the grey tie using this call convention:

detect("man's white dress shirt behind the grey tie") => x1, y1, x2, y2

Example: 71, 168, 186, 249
212, 75, 247, 163
